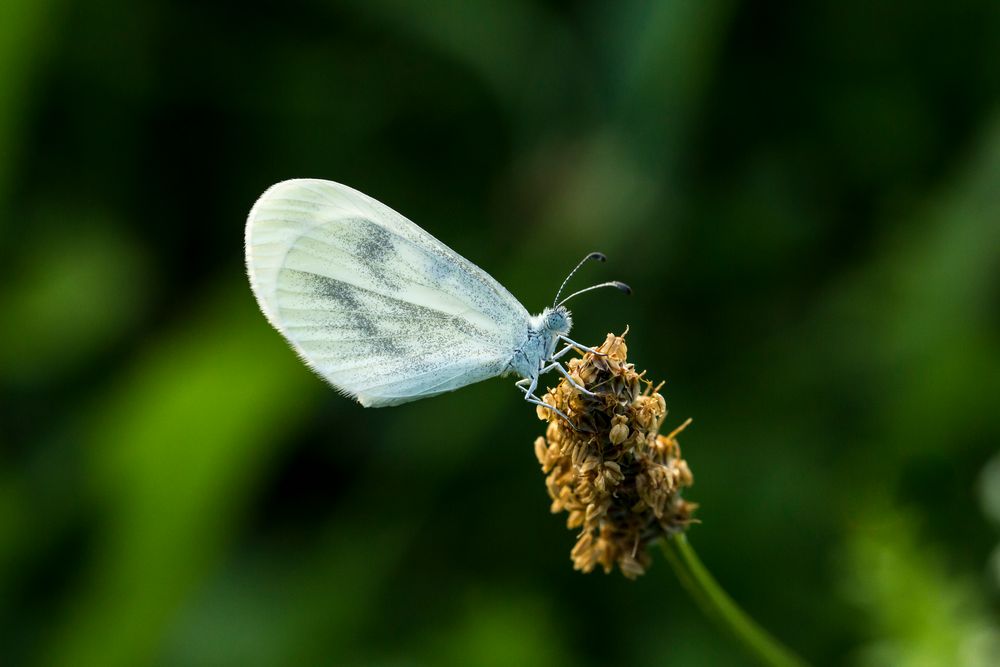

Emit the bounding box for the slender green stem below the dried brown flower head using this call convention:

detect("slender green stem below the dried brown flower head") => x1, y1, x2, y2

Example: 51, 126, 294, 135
663, 533, 806, 667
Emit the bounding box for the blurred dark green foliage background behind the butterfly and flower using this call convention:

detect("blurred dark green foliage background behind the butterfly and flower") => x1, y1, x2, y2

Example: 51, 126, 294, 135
0, 0, 1000, 667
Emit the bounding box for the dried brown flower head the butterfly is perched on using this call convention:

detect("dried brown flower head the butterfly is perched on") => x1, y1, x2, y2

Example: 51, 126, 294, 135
535, 334, 696, 579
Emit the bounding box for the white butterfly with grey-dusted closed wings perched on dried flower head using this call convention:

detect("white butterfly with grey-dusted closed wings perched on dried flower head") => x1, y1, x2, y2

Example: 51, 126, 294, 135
246, 179, 630, 421
